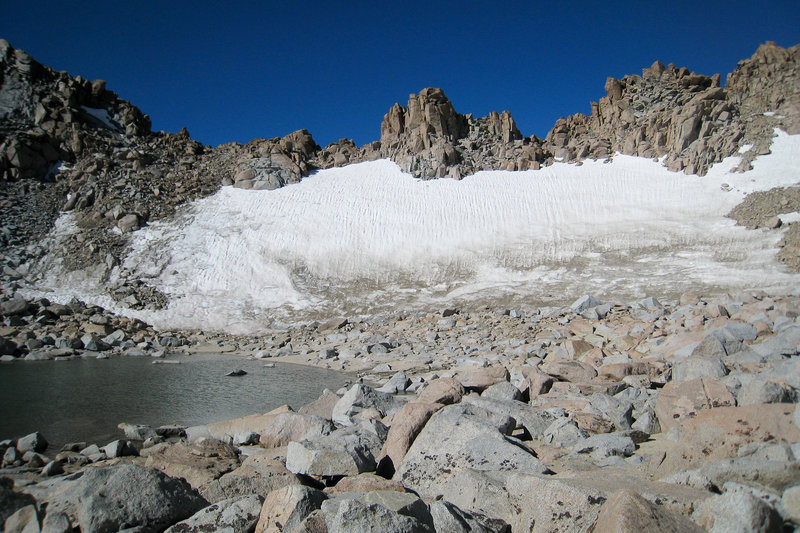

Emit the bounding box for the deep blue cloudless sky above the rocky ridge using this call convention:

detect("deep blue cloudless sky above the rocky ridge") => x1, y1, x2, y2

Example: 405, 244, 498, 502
0, 0, 800, 146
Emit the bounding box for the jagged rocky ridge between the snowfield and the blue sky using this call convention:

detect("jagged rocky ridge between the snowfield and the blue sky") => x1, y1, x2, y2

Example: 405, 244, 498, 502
0, 41, 800, 309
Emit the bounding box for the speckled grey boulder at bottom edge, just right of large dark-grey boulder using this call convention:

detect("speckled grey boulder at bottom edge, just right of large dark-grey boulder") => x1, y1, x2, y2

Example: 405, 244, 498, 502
166, 494, 261, 533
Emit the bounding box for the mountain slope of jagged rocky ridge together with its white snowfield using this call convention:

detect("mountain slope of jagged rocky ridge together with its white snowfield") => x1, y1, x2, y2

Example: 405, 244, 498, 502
0, 41, 800, 327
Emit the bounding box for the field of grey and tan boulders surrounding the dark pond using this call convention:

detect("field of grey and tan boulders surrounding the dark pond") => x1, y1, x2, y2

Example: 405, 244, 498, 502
0, 291, 800, 532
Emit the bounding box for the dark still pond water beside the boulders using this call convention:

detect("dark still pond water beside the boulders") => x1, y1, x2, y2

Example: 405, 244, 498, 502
0, 355, 348, 453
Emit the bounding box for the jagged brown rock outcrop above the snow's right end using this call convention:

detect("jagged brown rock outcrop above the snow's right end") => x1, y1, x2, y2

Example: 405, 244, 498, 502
545, 43, 800, 175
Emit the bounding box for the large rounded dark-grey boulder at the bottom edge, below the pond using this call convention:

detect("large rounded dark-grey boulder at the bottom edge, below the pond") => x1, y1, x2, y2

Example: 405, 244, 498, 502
47, 464, 208, 533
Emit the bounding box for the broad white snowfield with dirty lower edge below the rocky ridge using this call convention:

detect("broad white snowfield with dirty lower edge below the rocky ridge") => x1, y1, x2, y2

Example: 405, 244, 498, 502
32, 132, 800, 333
